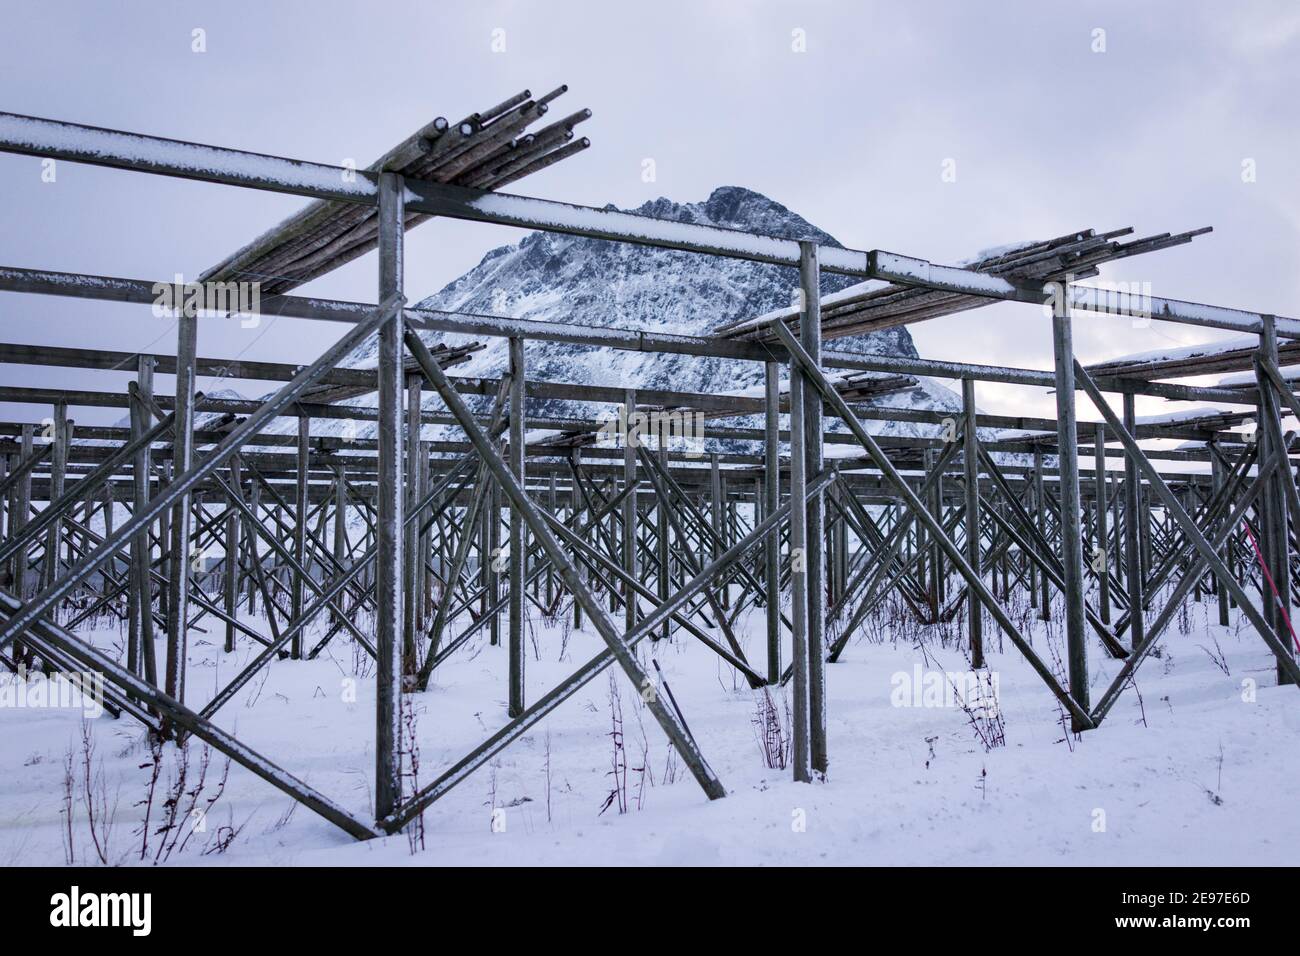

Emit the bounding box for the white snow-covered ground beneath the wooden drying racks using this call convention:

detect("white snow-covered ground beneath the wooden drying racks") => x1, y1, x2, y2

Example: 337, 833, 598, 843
0, 590, 1300, 866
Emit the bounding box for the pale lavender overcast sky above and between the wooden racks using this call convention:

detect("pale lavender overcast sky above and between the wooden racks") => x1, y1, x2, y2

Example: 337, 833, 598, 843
0, 0, 1300, 421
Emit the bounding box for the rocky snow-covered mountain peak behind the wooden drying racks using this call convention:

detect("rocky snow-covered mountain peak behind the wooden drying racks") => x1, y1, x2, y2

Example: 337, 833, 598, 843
350, 186, 959, 433
